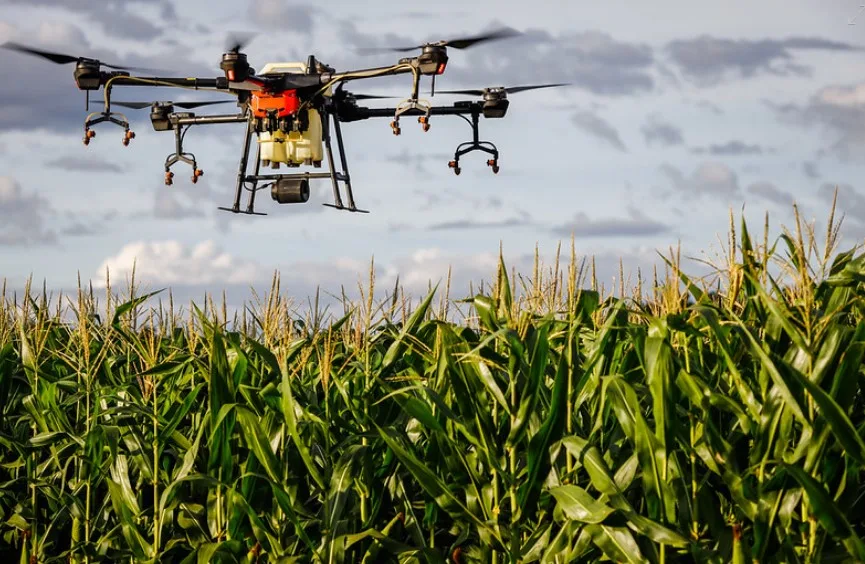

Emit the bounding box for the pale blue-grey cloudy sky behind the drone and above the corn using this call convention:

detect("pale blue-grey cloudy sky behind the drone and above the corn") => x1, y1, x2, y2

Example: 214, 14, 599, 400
0, 0, 865, 316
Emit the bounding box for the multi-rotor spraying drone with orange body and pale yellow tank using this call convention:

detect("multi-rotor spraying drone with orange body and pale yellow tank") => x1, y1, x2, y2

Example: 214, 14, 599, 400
0, 29, 566, 215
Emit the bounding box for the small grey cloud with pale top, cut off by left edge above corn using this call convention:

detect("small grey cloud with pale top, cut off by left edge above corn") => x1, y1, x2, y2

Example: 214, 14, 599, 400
0, 176, 57, 247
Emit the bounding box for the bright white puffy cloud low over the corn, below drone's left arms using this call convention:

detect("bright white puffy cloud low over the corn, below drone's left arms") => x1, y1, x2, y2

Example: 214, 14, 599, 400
94, 240, 267, 287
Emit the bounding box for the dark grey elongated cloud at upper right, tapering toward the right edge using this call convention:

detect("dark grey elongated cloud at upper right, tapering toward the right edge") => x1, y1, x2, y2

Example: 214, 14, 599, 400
665, 35, 861, 86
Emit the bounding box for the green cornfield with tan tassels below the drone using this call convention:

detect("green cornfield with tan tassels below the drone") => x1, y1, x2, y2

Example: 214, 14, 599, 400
0, 205, 865, 564
